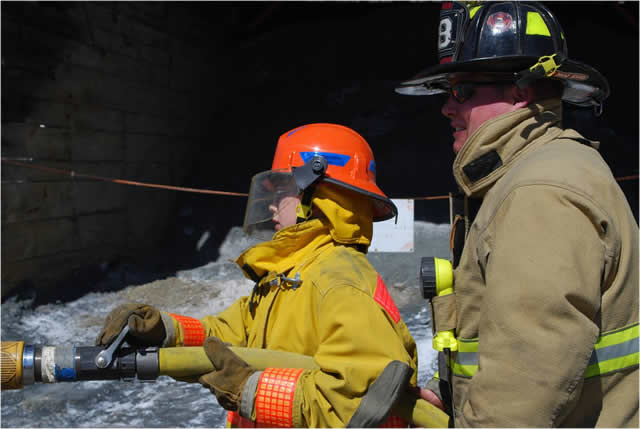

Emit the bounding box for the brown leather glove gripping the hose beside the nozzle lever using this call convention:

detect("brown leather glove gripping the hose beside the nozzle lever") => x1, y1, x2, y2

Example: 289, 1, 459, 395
95, 304, 167, 346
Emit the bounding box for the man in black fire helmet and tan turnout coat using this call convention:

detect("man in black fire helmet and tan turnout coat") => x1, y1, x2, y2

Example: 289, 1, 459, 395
396, 2, 640, 427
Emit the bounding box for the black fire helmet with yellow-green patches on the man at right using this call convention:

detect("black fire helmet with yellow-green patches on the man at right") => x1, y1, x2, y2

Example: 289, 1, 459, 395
396, 2, 609, 114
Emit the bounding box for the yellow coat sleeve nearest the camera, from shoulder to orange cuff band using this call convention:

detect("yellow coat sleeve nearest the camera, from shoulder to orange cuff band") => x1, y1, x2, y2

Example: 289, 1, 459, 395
293, 285, 417, 427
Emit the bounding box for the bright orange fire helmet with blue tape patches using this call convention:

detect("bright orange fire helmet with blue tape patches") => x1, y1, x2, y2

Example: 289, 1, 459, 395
271, 123, 398, 222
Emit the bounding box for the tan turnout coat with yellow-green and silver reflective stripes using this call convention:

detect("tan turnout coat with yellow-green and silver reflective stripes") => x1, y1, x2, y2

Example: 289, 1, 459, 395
453, 100, 639, 427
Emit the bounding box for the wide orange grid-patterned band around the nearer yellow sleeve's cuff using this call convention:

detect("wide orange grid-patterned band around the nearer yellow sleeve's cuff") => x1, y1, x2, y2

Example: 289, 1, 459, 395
255, 368, 303, 428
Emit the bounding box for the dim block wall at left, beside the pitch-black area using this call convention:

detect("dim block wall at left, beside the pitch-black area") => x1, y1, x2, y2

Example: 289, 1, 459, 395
2, 2, 222, 298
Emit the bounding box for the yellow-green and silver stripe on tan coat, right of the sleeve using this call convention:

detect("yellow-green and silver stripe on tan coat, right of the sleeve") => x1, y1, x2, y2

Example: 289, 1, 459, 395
584, 324, 640, 378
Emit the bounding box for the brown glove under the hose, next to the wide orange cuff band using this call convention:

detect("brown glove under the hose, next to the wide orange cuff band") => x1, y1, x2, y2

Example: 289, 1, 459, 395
198, 337, 257, 413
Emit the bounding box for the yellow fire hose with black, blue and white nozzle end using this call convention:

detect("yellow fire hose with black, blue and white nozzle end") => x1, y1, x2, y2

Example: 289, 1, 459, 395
0, 340, 449, 428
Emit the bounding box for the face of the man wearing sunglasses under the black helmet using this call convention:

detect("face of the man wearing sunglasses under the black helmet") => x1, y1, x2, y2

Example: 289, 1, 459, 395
441, 79, 526, 153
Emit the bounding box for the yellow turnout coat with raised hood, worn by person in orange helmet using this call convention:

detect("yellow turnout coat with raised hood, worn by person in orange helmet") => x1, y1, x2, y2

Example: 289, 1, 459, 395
168, 185, 417, 427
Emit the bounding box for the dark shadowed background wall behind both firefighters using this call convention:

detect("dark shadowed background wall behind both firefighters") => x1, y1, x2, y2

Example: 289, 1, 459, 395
1, 2, 638, 300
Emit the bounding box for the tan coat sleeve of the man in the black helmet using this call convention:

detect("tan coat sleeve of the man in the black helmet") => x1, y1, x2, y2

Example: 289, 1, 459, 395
455, 185, 607, 427
